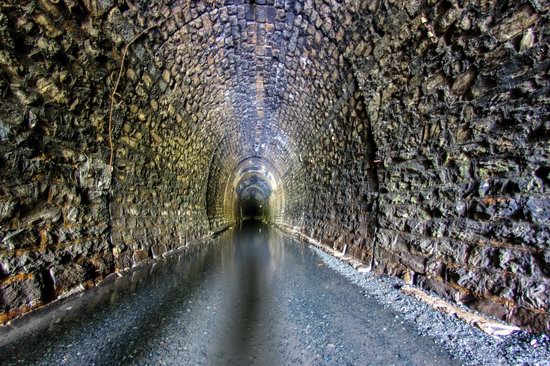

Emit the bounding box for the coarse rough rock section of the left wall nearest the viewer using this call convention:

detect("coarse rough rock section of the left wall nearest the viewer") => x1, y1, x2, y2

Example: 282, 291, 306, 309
0, 1, 121, 315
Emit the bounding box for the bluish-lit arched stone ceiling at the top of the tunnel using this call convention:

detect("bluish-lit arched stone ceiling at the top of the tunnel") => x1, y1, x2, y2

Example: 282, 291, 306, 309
136, 1, 360, 177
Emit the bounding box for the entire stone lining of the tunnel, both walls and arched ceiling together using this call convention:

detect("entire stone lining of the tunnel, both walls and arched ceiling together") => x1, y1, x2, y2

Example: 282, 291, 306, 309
0, 0, 550, 332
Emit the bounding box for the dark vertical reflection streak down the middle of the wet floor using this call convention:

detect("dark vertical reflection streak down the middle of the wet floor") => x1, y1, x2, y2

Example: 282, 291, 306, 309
214, 222, 281, 364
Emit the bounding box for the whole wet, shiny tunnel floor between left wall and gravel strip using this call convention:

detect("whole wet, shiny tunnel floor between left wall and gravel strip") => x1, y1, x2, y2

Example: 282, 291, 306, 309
0, 222, 457, 365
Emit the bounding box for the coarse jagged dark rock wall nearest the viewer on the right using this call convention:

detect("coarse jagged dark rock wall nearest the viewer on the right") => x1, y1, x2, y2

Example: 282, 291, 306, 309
353, 1, 550, 331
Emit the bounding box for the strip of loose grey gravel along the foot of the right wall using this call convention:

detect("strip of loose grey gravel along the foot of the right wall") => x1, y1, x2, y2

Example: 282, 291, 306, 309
310, 246, 550, 365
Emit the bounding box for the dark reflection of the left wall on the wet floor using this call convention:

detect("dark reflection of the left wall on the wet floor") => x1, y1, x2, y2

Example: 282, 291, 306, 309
0, 234, 220, 364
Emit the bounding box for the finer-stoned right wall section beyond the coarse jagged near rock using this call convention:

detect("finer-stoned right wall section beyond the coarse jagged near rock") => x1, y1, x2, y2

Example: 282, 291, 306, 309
277, 83, 377, 260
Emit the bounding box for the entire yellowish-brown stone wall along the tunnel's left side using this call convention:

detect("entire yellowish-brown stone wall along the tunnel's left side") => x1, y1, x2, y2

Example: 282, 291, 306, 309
0, 0, 216, 321
